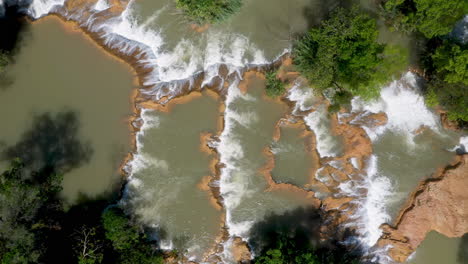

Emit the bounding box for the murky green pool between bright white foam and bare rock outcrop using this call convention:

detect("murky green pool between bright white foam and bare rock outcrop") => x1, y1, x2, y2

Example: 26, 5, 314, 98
373, 130, 458, 218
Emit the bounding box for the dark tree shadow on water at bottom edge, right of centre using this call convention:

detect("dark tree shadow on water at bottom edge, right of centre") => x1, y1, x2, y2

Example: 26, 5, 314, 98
248, 207, 367, 263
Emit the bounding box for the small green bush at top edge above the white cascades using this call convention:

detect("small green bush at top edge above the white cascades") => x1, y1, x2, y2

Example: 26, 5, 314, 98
176, 0, 242, 24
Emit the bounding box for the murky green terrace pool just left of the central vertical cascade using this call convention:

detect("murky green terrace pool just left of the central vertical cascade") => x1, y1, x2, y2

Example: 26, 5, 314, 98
124, 95, 222, 260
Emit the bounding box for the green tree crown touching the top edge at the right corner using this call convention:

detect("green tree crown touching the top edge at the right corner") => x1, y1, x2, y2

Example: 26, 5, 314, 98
382, 0, 468, 38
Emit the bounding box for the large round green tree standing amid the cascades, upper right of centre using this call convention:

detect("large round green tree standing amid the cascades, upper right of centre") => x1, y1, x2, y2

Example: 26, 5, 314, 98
293, 7, 407, 99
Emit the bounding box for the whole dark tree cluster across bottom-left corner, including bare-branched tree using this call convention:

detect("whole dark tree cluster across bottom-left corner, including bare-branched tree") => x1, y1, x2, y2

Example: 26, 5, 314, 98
0, 159, 163, 264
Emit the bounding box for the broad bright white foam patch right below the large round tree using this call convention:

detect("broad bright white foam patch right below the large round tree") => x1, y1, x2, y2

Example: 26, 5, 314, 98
352, 72, 440, 143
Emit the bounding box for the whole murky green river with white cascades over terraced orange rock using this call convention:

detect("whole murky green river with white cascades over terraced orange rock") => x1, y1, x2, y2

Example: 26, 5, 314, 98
0, 0, 466, 264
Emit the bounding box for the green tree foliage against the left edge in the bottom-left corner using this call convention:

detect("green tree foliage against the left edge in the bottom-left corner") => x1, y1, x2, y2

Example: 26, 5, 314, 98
0, 159, 62, 264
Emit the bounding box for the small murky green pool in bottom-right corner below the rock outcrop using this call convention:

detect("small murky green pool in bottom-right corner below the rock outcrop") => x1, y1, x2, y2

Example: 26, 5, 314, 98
407, 231, 462, 264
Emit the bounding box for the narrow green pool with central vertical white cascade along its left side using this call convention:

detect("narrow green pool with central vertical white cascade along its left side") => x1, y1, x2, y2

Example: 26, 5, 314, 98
220, 77, 316, 241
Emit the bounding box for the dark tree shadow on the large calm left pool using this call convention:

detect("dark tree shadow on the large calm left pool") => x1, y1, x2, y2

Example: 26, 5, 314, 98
1, 111, 93, 174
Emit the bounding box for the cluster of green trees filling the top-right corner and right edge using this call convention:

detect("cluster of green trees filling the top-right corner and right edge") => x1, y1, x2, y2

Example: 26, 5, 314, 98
380, 0, 468, 124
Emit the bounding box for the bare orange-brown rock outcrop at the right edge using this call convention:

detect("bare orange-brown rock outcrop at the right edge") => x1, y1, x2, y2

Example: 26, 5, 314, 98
378, 155, 468, 262
